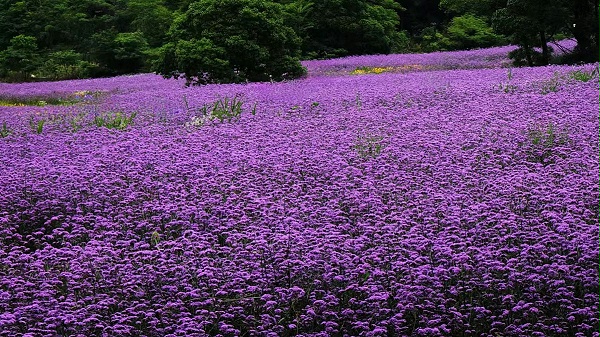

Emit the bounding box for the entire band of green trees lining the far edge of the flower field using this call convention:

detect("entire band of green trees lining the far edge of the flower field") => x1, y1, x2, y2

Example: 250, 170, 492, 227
0, 0, 600, 84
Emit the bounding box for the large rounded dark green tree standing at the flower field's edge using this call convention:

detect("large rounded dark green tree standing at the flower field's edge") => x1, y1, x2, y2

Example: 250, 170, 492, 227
154, 0, 305, 85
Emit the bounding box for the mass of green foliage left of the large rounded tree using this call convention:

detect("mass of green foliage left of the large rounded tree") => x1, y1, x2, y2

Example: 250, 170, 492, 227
0, 0, 174, 81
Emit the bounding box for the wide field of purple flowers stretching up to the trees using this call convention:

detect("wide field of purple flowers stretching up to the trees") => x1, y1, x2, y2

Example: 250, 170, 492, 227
0, 45, 600, 337
